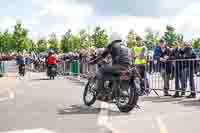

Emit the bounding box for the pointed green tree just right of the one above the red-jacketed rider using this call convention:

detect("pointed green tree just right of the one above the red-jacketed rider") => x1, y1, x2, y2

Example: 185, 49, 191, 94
60, 29, 72, 53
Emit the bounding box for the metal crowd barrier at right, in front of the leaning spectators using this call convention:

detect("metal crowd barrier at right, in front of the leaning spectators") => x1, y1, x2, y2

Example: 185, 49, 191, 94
146, 59, 200, 93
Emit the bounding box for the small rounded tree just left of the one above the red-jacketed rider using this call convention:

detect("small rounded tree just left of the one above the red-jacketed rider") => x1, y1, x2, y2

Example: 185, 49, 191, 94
36, 38, 47, 53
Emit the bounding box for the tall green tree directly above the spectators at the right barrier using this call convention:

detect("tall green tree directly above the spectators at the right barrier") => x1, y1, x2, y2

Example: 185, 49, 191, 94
164, 25, 177, 46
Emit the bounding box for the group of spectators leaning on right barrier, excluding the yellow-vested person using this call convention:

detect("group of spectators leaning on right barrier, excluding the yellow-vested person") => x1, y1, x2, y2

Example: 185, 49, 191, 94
153, 39, 199, 98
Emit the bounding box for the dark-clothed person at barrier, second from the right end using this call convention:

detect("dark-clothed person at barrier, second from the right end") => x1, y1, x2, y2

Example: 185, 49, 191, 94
170, 42, 185, 98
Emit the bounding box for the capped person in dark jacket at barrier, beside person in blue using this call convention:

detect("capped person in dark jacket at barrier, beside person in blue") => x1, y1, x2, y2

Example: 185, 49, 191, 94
159, 39, 171, 96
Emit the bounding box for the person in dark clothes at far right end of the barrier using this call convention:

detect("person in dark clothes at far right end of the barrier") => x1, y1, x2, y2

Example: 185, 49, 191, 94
183, 42, 196, 98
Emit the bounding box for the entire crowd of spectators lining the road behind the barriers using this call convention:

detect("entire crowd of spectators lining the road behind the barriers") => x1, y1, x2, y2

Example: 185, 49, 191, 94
0, 36, 199, 98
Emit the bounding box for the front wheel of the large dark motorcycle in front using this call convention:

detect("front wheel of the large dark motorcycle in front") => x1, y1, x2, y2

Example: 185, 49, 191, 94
83, 80, 97, 106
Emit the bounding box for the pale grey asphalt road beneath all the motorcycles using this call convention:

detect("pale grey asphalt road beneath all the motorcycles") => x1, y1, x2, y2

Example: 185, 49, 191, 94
0, 61, 200, 133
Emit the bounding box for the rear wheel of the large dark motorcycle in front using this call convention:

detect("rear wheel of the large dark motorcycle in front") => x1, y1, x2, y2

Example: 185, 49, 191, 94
117, 86, 139, 113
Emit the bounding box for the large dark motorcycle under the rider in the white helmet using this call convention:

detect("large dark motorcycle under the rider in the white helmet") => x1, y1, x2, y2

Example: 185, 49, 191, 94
83, 62, 141, 113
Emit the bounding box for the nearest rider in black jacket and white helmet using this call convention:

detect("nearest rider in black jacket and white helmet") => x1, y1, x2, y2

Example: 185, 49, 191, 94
89, 32, 141, 97
